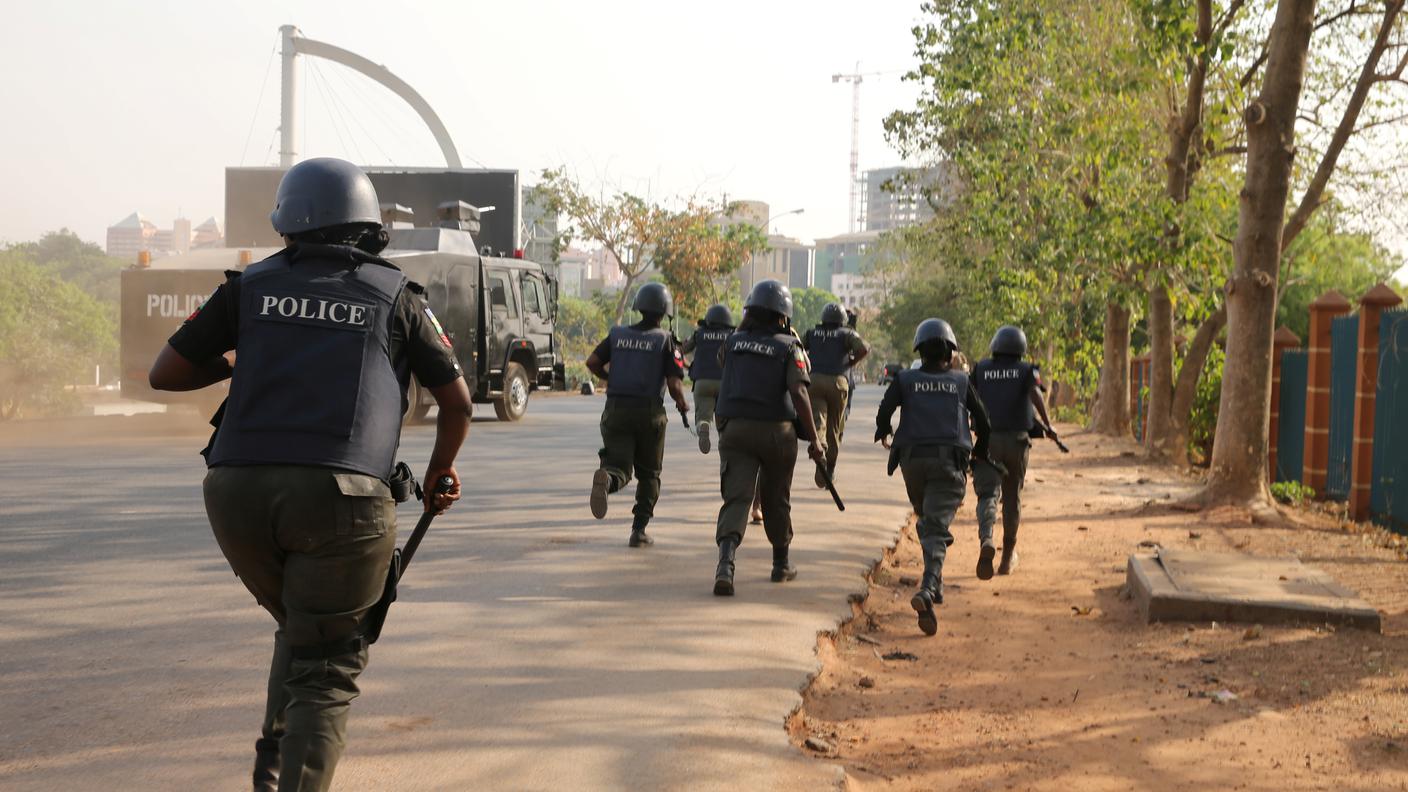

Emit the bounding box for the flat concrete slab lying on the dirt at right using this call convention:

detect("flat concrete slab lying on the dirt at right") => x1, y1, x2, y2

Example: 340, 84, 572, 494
1126, 548, 1381, 633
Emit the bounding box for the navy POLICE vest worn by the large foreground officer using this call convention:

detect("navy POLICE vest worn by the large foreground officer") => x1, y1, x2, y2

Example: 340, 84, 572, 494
208, 245, 407, 479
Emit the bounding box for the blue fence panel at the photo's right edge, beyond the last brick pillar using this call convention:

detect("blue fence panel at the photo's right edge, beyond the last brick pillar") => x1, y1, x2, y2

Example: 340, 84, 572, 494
1369, 310, 1408, 534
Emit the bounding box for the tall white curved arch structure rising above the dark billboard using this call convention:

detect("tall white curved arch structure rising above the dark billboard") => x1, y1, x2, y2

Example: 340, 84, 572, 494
279, 25, 460, 169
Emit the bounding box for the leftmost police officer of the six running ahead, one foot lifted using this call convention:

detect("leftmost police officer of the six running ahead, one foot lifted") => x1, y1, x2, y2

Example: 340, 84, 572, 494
587, 283, 690, 547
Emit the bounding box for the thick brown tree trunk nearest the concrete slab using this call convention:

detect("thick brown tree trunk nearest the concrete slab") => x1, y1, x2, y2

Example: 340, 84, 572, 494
1202, 0, 1315, 510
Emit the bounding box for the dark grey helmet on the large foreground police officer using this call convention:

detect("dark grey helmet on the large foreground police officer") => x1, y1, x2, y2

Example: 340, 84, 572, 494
269, 156, 382, 234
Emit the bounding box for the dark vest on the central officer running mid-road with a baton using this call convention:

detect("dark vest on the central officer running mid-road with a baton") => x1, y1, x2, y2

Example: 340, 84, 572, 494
714, 333, 797, 421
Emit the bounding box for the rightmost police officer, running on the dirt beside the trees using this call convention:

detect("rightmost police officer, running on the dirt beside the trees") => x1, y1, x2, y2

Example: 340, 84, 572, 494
973, 324, 1056, 572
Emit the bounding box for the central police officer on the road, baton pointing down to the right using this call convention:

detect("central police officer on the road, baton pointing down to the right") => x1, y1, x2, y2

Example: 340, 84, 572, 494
714, 280, 825, 596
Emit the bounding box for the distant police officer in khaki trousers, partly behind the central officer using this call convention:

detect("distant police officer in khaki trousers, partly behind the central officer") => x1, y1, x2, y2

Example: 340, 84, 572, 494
803, 303, 870, 488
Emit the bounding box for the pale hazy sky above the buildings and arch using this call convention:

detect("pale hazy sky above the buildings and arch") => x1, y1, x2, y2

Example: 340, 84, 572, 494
0, 0, 919, 244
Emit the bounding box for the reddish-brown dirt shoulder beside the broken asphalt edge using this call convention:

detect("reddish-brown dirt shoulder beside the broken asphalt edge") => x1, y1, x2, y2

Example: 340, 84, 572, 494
788, 431, 1408, 792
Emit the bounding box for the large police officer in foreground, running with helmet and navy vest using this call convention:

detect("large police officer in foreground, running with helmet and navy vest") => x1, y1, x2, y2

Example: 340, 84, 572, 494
149, 159, 470, 791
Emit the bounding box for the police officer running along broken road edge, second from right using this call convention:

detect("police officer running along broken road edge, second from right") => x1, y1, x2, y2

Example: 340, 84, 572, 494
876, 318, 988, 636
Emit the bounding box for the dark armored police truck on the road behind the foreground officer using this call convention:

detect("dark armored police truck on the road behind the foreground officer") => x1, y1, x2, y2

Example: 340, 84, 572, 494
121, 202, 566, 421
